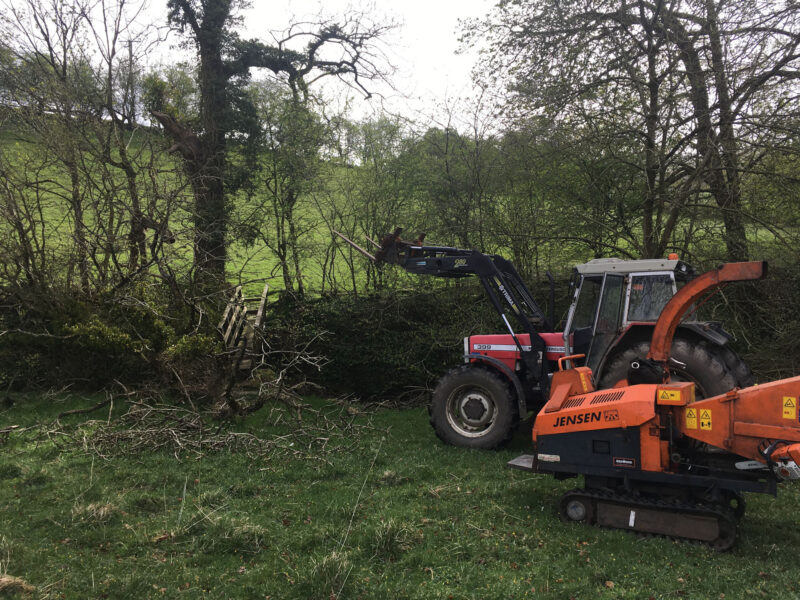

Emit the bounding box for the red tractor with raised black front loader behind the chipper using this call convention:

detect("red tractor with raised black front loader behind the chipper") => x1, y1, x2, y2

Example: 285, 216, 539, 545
339, 229, 754, 448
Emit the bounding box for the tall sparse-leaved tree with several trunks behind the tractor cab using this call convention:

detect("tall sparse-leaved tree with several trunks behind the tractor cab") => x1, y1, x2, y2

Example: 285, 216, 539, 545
473, 0, 800, 260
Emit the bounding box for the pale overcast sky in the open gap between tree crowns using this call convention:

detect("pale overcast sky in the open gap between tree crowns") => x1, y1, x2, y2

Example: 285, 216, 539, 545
151, 0, 495, 119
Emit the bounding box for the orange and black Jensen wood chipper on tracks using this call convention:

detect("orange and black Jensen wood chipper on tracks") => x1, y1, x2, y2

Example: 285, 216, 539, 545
509, 262, 800, 550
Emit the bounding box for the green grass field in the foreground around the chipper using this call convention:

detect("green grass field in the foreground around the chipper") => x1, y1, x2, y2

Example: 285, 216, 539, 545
0, 396, 800, 599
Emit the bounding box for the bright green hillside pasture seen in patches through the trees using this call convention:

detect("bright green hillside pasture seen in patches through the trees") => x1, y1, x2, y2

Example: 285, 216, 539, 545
0, 123, 793, 296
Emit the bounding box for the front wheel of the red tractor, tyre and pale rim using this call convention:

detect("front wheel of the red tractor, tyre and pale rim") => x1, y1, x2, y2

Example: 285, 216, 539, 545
428, 365, 519, 449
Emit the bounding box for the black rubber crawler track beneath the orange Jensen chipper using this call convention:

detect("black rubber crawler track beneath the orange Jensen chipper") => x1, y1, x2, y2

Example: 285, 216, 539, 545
560, 489, 736, 552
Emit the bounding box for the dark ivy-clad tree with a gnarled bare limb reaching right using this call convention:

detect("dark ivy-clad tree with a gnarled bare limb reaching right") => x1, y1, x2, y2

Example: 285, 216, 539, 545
153, 0, 394, 286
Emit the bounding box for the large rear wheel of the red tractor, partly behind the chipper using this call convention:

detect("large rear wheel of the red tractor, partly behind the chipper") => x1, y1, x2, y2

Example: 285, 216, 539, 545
599, 337, 753, 398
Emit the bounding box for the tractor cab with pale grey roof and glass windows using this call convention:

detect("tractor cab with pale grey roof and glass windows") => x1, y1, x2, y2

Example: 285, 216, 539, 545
564, 255, 695, 372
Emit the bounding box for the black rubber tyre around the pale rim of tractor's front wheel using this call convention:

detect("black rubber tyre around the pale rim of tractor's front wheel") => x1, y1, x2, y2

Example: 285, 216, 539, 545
428, 365, 519, 450
